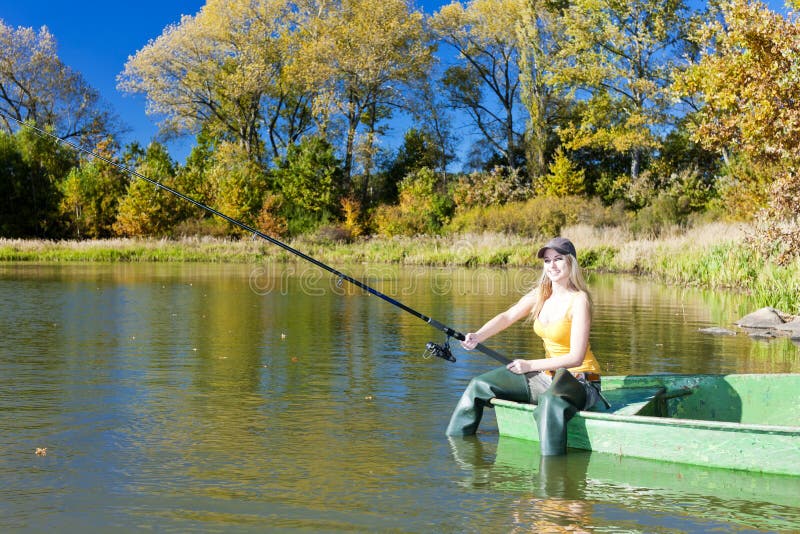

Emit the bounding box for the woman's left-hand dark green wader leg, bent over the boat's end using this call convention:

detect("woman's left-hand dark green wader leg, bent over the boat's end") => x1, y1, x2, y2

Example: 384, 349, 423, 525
447, 367, 530, 436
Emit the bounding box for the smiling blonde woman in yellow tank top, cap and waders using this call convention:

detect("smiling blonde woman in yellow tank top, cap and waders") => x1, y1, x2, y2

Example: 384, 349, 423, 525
447, 237, 601, 436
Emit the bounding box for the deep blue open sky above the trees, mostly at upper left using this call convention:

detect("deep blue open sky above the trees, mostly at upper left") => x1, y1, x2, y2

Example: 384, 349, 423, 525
0, 0, 449, 162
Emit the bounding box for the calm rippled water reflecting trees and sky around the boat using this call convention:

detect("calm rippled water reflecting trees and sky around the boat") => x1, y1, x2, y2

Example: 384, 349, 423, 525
0, 263, 800, 532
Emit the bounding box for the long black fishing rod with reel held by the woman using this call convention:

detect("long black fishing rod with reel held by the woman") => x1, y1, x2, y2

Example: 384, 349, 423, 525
0, 116, 511, 364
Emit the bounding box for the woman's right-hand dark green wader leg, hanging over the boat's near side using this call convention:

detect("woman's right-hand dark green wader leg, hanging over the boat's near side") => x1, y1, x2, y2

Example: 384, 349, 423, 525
533, 369, 586, 456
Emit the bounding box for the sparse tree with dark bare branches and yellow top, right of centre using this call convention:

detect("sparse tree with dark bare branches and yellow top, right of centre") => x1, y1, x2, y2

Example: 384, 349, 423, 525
431, 0, 525, 170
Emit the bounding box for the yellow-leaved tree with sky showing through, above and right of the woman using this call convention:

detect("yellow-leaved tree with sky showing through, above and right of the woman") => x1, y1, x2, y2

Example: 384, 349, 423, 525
550, 0, 691, 181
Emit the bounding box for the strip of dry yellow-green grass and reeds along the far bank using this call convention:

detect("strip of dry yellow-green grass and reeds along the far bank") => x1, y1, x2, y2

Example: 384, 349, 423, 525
0, 223, 800, 314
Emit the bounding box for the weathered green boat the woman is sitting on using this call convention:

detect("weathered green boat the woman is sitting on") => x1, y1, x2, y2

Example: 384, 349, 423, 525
492, 374, 800, 476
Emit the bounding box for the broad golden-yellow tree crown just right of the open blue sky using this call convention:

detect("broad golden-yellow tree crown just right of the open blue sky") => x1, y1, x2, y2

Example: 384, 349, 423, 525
118, 0, 310, 160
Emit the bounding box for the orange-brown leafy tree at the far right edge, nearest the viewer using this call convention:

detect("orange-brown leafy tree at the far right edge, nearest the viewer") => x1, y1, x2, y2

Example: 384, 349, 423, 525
679, 0, 800, 262
